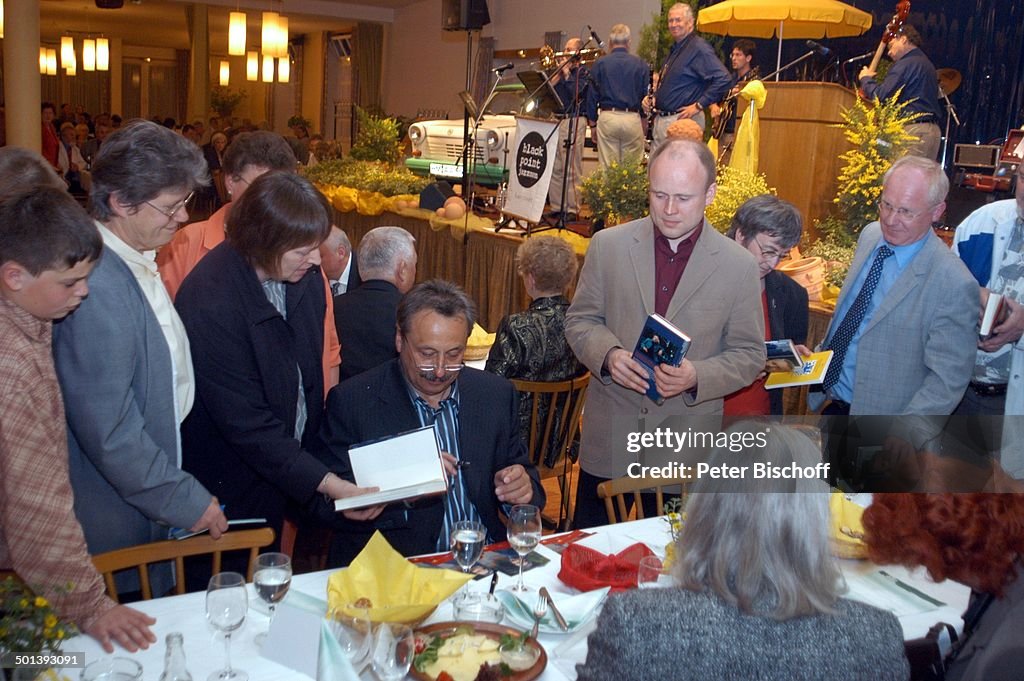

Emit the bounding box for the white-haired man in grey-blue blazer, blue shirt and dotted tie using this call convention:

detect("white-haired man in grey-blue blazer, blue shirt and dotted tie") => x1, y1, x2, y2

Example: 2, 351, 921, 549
808, 157, 980, 490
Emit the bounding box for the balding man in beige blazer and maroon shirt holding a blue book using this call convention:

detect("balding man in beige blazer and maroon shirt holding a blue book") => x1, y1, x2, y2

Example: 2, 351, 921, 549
565, 139, 765, 527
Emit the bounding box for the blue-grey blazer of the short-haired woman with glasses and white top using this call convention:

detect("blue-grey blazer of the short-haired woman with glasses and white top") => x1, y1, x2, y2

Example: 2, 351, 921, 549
53, 248, 212, 586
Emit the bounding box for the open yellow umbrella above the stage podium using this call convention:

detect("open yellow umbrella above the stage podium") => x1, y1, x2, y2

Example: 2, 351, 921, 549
697, 0, 871, 69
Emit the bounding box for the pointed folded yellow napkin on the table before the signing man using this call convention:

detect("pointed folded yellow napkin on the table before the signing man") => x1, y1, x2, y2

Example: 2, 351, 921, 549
327, 531, 473, 623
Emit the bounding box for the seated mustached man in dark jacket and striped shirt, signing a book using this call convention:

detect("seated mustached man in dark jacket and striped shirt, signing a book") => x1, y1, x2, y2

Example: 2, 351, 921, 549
321, 280, 545, 565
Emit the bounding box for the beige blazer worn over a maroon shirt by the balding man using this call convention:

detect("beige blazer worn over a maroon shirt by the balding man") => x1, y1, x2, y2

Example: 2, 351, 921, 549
565, 217, 765, 477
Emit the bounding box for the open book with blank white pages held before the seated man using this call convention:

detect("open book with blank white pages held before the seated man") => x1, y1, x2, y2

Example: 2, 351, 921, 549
334, 426, 447, 511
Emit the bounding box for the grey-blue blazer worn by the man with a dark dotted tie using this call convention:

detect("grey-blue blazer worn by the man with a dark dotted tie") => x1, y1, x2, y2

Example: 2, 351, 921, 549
808, 222, 981, 416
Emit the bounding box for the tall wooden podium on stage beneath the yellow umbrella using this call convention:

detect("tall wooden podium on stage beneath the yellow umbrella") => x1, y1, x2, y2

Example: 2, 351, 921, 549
740, 81, 856, 238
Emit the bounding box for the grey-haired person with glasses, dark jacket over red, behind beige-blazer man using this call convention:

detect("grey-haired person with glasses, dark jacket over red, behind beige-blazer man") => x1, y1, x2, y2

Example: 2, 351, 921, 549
725, 194, 811, 416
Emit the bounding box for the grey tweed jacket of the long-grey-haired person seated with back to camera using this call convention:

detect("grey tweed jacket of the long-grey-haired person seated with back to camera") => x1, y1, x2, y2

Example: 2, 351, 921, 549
577, 588, 909, 681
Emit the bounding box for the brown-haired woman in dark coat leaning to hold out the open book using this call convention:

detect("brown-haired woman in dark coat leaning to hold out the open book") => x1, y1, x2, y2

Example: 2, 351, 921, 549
175, 171, 385, 557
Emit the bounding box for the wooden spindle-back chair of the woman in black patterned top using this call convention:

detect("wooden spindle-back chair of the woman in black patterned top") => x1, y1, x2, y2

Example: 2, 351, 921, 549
512, 373, 590, 529
